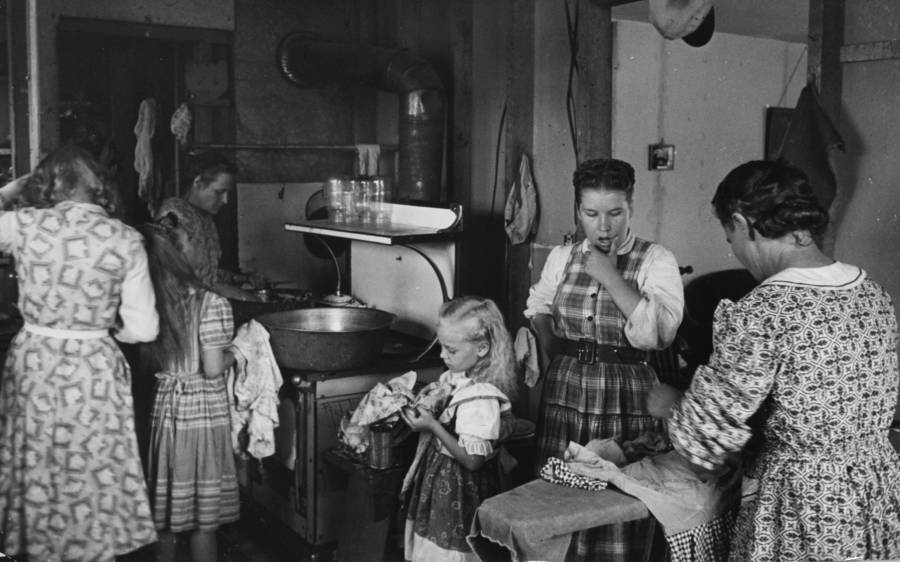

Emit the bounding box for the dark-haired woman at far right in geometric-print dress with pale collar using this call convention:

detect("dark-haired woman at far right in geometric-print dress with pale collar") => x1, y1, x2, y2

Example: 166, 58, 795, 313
650, 161, 900, 562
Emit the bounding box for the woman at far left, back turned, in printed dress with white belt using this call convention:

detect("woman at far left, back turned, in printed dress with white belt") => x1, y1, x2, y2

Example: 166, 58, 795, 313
0, 146, 158, 562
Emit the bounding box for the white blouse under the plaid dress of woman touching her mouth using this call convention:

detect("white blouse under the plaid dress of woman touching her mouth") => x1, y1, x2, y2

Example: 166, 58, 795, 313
525, 231, 684, 349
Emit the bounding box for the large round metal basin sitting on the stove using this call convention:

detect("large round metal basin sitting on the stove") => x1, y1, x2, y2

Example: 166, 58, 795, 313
256, 308, 394, 371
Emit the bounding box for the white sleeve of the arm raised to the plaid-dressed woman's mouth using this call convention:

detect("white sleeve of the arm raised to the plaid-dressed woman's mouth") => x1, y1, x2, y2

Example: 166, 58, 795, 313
625, 244, 684, 349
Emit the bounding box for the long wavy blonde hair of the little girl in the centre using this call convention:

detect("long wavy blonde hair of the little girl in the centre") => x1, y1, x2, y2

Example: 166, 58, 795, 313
438, 297, 516, 400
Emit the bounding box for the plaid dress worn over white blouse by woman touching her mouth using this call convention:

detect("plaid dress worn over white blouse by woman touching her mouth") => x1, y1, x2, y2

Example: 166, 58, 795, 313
535, 238, 662, 562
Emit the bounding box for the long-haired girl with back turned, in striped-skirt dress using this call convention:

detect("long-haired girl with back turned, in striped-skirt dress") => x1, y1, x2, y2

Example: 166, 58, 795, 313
143, 209, 239, 562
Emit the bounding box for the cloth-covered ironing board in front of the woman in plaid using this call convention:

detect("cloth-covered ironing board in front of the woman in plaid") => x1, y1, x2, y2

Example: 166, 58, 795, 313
469, 480, 650, 562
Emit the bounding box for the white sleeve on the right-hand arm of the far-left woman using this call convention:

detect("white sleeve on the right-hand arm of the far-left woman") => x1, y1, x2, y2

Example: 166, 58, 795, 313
115, 239, 159, 343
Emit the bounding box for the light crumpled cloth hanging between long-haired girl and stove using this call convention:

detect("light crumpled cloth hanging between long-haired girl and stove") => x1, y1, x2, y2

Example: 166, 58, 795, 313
227, 320, 282, 459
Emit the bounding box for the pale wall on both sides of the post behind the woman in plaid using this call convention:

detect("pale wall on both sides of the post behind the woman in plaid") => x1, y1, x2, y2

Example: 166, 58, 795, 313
534, 15, 806, 279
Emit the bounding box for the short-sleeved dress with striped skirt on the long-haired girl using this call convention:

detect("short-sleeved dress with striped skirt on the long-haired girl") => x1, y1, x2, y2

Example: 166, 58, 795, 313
149, 291, 239, 533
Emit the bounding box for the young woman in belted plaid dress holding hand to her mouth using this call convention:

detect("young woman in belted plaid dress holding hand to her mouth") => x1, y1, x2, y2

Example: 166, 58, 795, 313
525, 158, 684, 562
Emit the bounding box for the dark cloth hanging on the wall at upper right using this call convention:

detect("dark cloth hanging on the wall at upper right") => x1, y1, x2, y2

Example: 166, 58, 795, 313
778, 84, 844, 211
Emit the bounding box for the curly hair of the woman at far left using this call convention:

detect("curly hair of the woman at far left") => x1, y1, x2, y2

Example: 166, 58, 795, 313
22, 144, 120, 216
